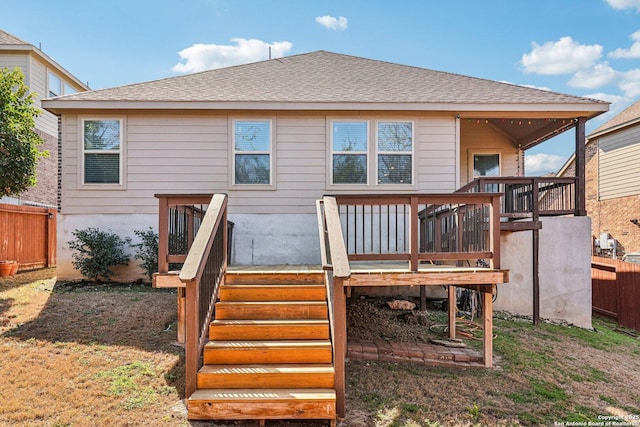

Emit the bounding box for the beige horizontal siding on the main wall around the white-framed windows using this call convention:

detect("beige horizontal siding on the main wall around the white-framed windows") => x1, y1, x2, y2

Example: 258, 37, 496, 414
62, 112, 464, 214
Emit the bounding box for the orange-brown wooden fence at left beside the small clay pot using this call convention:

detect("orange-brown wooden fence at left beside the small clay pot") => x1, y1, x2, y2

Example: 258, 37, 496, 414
0, 204, 56, 271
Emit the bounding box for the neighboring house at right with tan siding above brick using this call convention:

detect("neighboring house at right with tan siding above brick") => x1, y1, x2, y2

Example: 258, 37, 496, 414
558, 101, 640, 258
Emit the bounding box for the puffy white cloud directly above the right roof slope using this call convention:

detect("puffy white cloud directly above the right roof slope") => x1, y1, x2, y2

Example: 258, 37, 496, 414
522, 37, 602, 75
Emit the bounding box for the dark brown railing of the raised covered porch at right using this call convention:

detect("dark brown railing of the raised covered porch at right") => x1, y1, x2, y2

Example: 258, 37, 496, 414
458, 177, 579, 220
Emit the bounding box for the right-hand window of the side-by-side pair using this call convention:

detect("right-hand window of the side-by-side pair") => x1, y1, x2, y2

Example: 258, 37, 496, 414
377, 122, 413, 184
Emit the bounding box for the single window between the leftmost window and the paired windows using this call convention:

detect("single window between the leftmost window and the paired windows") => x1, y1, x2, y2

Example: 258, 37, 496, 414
233, 120, 272, 184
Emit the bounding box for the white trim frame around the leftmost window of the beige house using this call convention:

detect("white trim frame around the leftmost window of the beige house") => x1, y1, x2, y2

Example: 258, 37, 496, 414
78, 116, 127, 190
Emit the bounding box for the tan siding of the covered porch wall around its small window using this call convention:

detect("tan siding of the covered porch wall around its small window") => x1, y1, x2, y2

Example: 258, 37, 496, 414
460, 119, 520, 185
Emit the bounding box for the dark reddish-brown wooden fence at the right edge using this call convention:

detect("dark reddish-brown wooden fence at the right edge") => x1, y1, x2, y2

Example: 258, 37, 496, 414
591, 256, 640, 331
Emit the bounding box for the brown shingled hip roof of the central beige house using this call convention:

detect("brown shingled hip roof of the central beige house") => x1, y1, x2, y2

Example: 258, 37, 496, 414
48, 51, 608, 112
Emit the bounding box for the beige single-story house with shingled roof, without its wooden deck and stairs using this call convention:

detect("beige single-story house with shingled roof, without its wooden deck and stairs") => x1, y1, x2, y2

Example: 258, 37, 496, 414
43, 51, 608, 327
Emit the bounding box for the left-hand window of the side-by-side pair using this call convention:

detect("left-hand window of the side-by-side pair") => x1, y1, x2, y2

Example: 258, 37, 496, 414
331, 122, 369, 184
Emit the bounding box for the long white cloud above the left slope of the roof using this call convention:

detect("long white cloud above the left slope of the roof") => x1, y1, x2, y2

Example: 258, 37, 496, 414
171, 38, 293, 73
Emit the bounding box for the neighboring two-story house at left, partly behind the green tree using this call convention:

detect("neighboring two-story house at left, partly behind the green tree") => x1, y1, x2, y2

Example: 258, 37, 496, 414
0, 30, 89, 206
